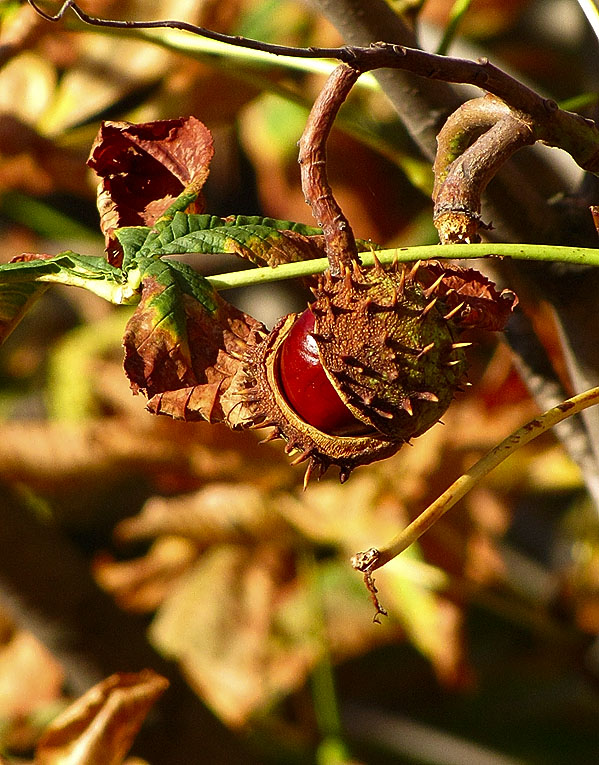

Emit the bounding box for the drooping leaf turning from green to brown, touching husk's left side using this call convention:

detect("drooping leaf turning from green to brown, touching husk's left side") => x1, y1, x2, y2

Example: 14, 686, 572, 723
123, 259, 261, 422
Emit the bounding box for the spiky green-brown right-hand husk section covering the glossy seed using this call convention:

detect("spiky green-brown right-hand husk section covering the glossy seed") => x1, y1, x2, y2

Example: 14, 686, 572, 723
312, 266, 466, 441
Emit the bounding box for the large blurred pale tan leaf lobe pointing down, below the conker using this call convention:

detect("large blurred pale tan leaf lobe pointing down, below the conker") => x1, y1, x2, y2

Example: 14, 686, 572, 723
151, 545, 319, 726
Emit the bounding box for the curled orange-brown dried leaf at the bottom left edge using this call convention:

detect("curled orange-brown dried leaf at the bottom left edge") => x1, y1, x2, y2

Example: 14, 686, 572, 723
35, 670, 168, 765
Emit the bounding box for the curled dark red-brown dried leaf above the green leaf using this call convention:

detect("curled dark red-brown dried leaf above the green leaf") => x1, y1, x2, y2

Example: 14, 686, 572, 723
87, 117, 214, 265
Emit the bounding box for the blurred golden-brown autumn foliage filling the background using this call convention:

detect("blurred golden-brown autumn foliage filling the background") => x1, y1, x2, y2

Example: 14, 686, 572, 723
0, 0, 599, 765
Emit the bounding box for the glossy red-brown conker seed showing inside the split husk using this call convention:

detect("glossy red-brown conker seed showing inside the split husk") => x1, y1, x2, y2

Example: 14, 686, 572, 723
279, 308, 364, 435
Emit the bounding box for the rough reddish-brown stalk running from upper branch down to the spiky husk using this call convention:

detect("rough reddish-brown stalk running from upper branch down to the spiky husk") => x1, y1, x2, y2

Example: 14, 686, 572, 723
299, 64, 360, 275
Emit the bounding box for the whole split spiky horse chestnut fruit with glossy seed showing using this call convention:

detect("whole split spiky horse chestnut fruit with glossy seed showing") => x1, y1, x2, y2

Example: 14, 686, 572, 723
238, 261, 515, 481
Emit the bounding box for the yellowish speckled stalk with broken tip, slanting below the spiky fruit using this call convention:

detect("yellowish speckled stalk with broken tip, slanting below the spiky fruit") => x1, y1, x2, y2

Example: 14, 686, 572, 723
351, 387, 599, 574
